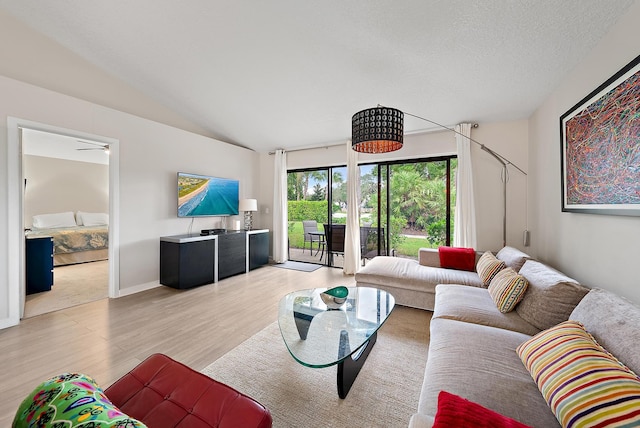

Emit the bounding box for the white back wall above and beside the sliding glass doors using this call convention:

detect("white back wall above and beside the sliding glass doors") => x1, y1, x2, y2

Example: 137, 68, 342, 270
260, 120, 528, 251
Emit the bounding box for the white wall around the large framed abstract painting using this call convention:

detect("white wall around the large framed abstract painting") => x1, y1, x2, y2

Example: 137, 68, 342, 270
529, 2, 640, 303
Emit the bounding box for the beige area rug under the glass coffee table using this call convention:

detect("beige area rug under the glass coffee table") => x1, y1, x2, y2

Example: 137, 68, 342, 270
203, 306, 431, 428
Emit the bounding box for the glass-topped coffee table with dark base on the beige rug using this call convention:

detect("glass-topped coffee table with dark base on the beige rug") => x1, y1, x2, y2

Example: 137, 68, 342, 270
278, 287, 395, 398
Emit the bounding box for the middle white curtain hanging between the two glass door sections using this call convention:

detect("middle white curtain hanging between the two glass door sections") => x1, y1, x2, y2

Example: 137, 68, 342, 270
342, 142, 360, 275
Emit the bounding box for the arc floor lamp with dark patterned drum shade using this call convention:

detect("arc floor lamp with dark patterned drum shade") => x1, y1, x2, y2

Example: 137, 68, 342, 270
351, 104, 528, 246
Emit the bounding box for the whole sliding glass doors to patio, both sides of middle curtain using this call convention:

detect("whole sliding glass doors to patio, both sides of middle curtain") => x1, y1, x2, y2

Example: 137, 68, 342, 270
287, 156, 457, 267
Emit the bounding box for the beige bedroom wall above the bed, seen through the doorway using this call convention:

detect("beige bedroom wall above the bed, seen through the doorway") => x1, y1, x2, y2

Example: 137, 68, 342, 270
23, 155, 109, 227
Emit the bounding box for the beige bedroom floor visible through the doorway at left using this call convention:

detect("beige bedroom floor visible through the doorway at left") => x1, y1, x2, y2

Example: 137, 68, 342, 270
24, 260, 109, 318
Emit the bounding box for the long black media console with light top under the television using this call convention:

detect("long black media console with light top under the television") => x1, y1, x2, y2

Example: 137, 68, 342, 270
160, 229, 269, 289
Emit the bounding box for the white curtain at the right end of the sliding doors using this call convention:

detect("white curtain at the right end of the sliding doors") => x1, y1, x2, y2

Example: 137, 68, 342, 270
453, 123, 476, 248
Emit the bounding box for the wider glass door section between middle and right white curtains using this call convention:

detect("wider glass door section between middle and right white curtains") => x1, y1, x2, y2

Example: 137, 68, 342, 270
360, 156, 457, 261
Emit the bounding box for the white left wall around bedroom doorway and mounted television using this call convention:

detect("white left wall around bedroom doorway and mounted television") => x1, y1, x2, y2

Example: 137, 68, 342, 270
0, 76, 260, 327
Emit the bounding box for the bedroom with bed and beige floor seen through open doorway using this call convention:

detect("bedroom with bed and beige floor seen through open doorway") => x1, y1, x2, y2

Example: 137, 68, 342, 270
22, 128, 110, 318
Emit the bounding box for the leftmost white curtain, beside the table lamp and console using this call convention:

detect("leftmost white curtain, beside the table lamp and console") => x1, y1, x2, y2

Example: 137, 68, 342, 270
273, 150, 289, 263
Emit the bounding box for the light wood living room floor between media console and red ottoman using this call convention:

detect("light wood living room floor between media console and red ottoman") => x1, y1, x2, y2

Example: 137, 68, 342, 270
0, 266, 355, 427
